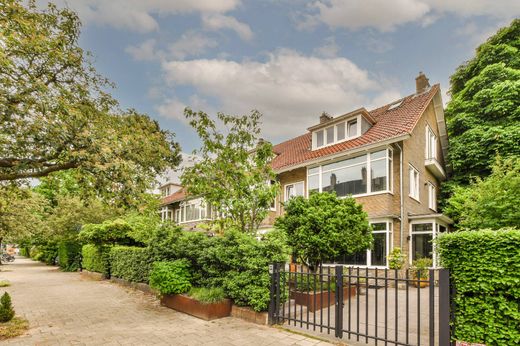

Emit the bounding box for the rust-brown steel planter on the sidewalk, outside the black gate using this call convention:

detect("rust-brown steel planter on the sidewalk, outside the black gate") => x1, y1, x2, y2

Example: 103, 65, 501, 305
161, 294, 231, 321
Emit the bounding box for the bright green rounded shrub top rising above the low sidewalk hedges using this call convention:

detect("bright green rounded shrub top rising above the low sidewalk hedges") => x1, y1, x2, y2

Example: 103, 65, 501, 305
79, 219, 133, 245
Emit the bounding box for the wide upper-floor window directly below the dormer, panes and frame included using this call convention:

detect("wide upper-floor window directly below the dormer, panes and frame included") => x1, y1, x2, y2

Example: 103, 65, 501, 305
307, 149, 392, 197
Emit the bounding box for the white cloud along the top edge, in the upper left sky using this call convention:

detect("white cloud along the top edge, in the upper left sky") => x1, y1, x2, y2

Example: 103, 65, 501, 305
40, 0, 240, 32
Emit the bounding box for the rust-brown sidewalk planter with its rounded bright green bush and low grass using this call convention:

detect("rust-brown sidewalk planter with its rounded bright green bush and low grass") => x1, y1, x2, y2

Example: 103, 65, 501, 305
150, 260, 231, 320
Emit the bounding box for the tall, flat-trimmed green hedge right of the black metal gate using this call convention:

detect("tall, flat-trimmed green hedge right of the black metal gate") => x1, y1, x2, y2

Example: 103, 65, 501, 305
437, 229, 520, 346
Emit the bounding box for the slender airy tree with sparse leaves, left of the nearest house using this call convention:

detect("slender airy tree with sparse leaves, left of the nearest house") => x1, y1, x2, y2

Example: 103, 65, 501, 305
181, 109, 278, 234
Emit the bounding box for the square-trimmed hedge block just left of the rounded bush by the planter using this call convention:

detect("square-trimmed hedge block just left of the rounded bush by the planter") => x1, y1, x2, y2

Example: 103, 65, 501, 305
110, 246, 152, 283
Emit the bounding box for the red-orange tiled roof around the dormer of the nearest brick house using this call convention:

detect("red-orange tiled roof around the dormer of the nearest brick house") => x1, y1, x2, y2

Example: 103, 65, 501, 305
272, 84, 440, 171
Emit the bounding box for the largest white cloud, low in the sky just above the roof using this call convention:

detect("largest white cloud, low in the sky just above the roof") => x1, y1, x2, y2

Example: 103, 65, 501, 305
159, 50, 398, 138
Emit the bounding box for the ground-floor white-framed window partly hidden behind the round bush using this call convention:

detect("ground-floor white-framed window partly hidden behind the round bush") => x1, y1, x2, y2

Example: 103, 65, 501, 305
330, 221, 392, 267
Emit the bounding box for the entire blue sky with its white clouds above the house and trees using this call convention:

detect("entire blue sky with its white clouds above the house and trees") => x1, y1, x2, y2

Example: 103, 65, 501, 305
41, 0, 520, 152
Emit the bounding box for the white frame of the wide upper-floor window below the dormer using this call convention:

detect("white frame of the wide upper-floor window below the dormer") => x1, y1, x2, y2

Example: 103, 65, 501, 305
306, 147, 394, 198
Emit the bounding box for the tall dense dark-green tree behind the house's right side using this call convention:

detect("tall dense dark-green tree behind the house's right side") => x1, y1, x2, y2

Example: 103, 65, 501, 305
446, 19, 520, 189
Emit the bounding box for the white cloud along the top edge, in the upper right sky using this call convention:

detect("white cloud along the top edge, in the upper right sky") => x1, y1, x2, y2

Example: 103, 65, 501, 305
304, 0, 520, 31
